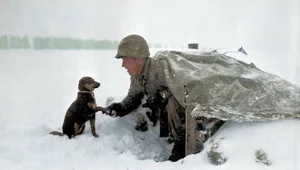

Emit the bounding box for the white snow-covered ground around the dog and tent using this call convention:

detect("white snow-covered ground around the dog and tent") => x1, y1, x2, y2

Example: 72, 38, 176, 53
0, 50, 300, 170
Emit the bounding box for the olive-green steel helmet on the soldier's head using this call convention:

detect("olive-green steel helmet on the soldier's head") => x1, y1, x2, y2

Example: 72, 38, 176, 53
116, 34, 150, 58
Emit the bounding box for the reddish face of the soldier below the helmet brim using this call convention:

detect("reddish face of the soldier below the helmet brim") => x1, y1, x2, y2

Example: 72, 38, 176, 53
122, 57, 142, 76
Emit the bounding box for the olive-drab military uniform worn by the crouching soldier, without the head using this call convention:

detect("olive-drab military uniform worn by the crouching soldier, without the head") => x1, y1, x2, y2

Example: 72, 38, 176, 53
108, 57, 193, 161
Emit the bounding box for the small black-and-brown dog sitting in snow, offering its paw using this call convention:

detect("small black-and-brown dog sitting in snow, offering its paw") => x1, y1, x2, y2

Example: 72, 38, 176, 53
50, 77, 106, 139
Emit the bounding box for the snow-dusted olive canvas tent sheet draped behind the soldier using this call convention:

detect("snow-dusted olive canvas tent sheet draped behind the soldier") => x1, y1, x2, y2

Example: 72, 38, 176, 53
155, 51, 300, 122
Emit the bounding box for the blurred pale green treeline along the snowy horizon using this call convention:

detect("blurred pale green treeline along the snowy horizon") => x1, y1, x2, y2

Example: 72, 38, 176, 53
0, 35, 161, 50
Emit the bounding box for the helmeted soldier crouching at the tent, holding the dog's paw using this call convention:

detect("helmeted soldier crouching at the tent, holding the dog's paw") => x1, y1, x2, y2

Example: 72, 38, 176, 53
107, 35, 225, 161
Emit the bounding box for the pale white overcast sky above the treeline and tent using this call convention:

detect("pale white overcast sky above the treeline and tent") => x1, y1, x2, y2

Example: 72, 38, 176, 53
0, 0, 300, 50
